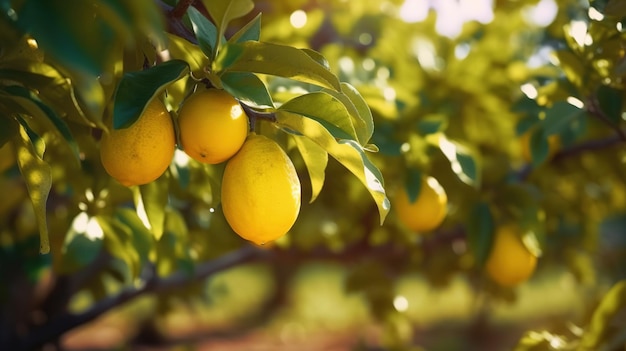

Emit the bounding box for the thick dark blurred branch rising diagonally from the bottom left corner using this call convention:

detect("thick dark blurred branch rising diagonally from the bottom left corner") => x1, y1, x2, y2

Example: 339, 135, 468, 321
7, 246, 268, 351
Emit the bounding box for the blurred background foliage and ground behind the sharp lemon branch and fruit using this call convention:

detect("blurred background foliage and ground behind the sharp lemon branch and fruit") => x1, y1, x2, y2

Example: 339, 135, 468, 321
0, 0, 626, 350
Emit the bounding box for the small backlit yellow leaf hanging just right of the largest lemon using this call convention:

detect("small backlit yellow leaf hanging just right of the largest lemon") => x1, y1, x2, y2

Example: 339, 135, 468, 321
293, 135, 328, 203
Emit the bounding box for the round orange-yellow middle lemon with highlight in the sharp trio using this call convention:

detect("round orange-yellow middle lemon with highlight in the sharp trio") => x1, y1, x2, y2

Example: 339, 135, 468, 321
178, 89, 248, 164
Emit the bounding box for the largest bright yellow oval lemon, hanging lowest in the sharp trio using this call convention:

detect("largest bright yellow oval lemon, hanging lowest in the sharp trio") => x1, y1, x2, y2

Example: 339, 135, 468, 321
222, 133, 301, 245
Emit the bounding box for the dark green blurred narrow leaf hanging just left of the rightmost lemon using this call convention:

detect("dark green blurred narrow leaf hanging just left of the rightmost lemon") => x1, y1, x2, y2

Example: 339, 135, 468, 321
467, 202, 495, 267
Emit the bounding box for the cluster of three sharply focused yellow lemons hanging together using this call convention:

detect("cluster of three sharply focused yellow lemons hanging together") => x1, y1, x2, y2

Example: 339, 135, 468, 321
100, 88, 301, 245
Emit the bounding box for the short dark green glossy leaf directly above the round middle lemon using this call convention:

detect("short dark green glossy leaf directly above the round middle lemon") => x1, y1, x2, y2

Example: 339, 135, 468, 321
222, 72, 274, 108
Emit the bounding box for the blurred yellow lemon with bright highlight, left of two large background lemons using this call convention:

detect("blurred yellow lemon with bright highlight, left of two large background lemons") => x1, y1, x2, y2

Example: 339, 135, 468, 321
394, 177, 448, 232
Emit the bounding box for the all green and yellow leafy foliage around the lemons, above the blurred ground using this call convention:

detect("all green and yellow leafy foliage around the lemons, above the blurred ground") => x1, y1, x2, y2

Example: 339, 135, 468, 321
0, 0, 626, 350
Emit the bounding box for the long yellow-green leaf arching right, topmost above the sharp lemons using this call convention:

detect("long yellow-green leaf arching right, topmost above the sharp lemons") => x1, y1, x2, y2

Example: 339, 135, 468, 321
216, 41, 341, 91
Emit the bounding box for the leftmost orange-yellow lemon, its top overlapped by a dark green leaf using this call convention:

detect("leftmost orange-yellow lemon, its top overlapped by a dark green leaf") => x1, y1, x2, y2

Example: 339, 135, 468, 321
100, 99, 176, 186
